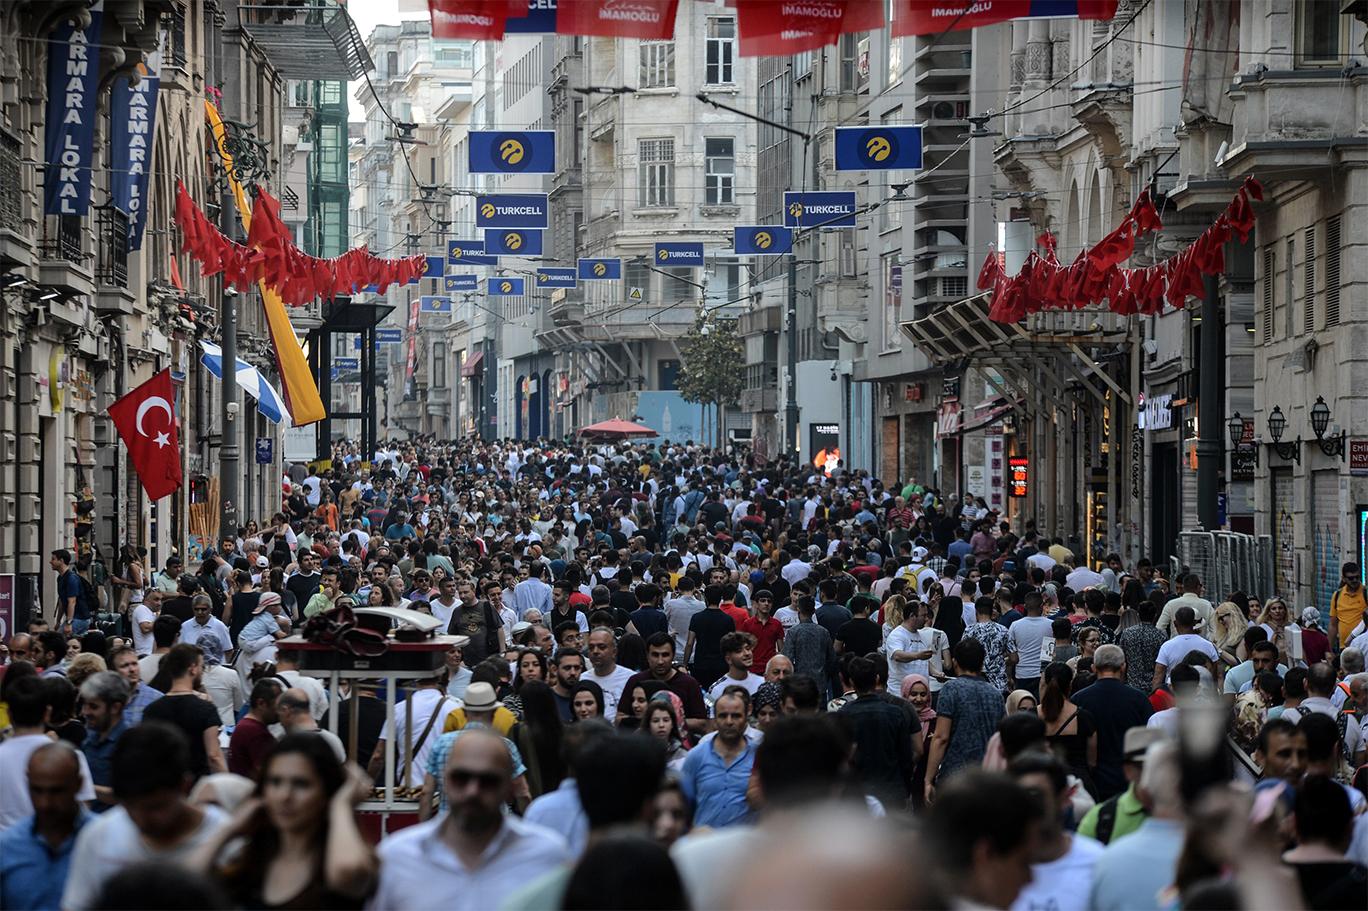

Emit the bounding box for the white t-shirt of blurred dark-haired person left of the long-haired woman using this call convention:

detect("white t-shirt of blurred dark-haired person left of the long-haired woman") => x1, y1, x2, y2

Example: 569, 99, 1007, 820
62, 806, 228, 911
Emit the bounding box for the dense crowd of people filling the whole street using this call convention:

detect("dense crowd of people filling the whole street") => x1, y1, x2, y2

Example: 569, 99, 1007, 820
0, 439, 1368, 911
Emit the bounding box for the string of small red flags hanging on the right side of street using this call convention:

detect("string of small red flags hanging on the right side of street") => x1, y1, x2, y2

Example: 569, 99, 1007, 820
978, 176, 1264, 323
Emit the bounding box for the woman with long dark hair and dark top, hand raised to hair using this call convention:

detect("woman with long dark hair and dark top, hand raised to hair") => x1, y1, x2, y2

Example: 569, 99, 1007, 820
192, 733, 379, 908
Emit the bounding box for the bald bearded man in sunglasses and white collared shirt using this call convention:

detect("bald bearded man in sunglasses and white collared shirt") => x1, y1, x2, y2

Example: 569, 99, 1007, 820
367, 730, 573, 911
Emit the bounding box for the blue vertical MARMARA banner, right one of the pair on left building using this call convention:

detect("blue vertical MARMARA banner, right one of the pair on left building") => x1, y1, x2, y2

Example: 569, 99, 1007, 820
109, 53, 161, 252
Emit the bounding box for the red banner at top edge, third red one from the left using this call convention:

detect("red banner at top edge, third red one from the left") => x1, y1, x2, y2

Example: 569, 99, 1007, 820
736, 0, 884, 57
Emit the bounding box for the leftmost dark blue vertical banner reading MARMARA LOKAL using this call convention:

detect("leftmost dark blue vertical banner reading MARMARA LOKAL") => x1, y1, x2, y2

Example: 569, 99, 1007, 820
42, 0, 104, 216
